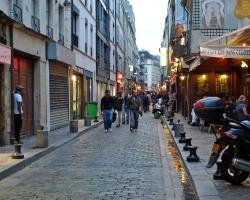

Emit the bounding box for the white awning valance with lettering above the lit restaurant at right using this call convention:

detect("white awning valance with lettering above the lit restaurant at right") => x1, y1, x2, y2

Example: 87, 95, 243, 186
200, 46, 250, 59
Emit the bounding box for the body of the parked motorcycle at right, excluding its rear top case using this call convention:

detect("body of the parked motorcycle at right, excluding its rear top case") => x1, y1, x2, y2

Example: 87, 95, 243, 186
207, 115, 250, 185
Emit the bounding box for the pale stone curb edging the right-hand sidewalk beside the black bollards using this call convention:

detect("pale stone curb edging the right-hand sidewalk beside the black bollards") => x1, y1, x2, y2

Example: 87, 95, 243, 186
164, 119, 221, 200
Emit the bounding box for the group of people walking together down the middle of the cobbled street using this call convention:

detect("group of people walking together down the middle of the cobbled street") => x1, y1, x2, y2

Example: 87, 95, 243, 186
101, 90, 151, 132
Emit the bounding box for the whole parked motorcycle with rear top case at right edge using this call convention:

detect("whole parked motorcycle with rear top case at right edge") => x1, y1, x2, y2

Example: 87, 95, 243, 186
195, 97, 250, 185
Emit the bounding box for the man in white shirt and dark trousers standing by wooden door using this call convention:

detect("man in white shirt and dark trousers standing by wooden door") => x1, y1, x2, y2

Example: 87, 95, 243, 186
13, 85, 24, 143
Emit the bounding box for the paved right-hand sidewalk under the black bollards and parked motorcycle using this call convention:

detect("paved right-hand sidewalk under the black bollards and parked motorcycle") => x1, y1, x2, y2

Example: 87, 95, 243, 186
166, 114, 250, 200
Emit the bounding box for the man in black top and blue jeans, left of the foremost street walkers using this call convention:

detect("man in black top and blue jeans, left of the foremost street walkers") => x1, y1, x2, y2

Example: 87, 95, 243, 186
101, 90, 114, 132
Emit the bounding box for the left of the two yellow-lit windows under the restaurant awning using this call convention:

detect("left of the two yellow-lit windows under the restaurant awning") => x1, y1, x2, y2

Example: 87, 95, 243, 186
194, 74, 210, 96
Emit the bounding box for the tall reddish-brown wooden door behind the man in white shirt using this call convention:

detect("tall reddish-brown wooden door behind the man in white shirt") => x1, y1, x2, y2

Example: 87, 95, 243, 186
13, 56, 34, 135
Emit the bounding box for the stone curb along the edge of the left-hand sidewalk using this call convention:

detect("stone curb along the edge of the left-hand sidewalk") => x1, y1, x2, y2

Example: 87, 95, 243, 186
0, 121, 103, 181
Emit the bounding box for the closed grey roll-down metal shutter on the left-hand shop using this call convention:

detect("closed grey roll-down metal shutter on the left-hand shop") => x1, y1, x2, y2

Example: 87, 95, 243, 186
49, 64, 69, 130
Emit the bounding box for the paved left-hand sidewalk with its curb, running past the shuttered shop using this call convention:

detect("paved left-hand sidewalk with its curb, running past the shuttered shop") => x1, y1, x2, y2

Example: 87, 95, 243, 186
0, 120, 102, 180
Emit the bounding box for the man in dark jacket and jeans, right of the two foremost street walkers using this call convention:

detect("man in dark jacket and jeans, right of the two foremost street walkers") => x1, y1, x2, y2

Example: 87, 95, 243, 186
128, 92, 142, 132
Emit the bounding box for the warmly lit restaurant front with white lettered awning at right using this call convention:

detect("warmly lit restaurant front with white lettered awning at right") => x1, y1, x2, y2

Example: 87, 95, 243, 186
187, 27, 250, 119
